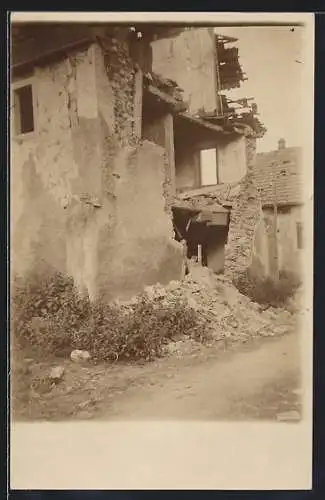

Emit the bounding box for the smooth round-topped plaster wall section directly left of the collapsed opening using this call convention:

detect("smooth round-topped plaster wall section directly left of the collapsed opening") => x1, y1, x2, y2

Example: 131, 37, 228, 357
98, 141, 182, 300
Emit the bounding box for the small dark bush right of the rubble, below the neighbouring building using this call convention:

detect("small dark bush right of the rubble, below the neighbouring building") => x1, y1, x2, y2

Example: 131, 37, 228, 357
234, 271, 301, 307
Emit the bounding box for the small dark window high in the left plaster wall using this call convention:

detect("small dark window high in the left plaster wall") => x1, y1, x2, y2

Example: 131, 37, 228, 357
13, 84, 35, 134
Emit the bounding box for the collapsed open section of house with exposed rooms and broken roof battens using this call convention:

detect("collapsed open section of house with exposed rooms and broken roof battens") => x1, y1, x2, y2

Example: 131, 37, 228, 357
152, 27, 269, 276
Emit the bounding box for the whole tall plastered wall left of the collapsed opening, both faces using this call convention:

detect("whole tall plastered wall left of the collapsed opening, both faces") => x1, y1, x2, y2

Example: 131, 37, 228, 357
11, 40, 181, 299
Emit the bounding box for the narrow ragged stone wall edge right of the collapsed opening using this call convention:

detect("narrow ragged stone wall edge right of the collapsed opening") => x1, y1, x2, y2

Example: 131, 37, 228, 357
225, 137, 263, 278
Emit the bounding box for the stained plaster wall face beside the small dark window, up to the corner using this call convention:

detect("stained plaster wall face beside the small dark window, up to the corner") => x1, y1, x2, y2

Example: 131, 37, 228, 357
11, 47, 105, 296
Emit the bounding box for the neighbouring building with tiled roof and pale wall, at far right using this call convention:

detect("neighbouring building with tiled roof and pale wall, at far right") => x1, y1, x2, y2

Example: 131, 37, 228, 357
255, 139, 304, 274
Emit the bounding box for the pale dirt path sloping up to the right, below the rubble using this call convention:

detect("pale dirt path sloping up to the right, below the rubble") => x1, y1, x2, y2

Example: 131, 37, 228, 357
102, 334, 300, 420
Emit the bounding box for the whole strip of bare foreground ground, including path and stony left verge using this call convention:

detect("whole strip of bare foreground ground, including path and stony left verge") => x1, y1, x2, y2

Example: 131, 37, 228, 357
12, 333, 301, 421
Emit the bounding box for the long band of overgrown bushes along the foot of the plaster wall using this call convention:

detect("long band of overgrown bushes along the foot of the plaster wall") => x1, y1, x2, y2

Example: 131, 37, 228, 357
12, 274, 205, 360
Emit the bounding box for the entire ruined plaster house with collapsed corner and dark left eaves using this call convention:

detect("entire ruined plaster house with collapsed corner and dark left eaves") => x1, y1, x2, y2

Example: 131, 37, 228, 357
11, 24, 264, 300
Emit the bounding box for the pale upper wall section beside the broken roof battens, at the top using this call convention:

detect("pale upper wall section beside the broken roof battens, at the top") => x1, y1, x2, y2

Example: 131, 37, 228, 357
151, 28, 217, 113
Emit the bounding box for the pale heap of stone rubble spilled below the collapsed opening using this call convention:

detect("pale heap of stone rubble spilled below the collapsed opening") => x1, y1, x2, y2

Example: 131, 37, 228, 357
126, 264, 297, 348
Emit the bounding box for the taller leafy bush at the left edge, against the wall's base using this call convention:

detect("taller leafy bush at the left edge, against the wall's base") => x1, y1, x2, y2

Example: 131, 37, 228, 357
11, 273, 90, 354
